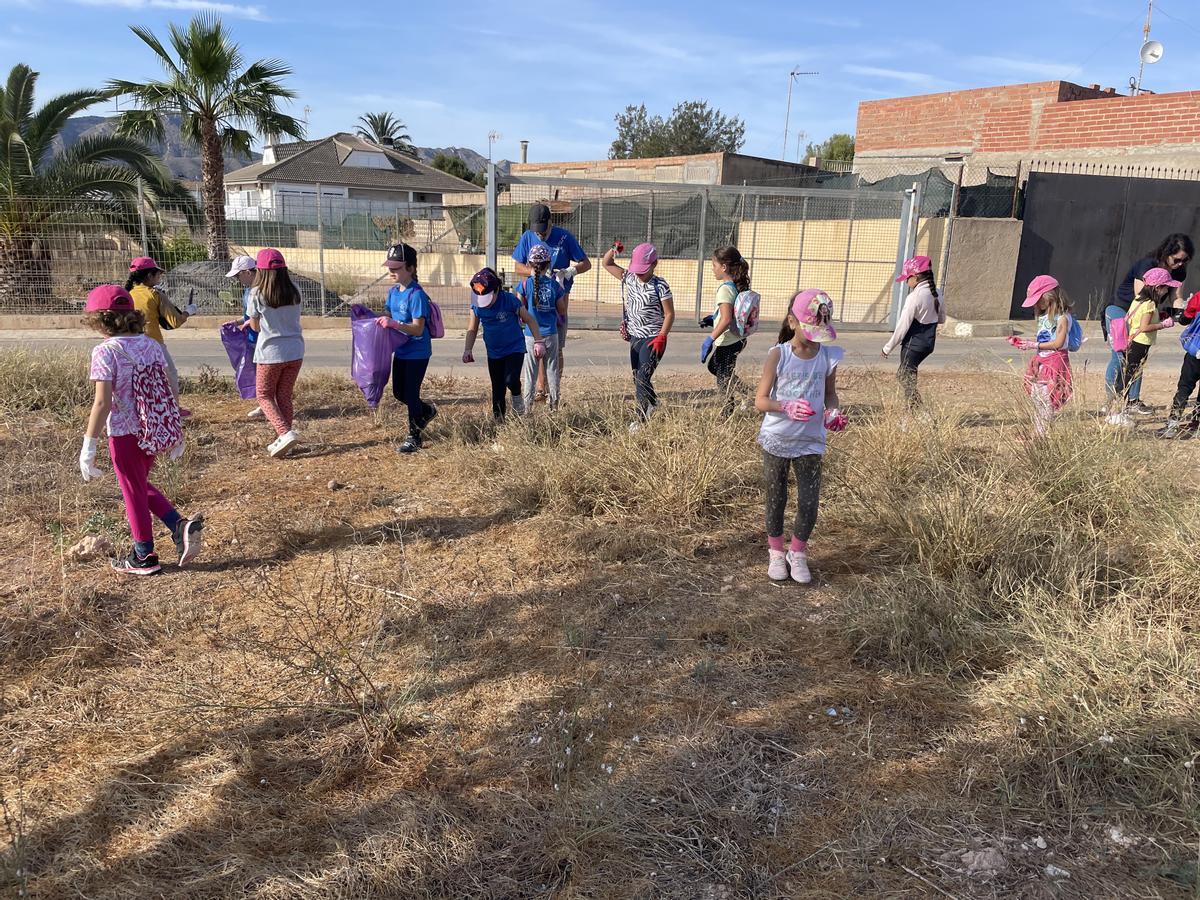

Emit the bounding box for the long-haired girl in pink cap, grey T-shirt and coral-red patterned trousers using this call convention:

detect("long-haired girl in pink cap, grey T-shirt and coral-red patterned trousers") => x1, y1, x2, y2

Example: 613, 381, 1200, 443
241, 247, 304, 456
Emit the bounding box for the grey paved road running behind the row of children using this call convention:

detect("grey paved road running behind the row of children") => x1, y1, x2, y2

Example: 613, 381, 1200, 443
0, 326, 1181, 378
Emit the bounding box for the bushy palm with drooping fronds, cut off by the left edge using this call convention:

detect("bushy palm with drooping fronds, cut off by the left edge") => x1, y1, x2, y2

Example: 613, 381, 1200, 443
0, 64, 197, 308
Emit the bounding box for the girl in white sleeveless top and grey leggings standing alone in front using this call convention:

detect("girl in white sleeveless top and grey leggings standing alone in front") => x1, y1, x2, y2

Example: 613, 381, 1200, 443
755, 290, 846, 584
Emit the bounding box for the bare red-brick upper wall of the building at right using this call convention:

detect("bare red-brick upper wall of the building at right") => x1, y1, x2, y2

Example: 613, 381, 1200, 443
854, 82, 1200, 178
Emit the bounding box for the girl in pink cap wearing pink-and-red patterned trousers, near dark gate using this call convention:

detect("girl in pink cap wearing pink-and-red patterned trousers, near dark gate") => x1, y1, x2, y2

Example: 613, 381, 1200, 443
1009, 275, 1072, 437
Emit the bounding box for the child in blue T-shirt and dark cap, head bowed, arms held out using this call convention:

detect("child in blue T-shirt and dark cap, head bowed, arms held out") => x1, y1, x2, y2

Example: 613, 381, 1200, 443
462, 269, 546, 422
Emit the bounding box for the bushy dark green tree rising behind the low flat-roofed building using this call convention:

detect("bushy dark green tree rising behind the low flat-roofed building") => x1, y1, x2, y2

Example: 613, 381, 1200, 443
608, 100, 745, 160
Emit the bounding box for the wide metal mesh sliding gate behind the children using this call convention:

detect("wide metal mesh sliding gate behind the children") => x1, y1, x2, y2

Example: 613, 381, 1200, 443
485, 166, 920, 328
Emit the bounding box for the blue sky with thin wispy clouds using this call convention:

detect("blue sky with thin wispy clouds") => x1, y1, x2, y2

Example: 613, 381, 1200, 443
0, 0, 1200, 161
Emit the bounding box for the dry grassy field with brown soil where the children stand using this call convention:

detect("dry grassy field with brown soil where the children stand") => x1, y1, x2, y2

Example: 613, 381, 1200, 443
0, 353, 1200, 900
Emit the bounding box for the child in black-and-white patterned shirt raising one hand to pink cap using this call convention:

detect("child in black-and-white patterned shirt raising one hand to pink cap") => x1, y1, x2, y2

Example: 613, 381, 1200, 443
600, 242, 674, 432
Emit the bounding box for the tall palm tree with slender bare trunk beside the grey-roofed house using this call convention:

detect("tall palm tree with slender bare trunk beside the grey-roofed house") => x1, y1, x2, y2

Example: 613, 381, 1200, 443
109, 14, 304, 259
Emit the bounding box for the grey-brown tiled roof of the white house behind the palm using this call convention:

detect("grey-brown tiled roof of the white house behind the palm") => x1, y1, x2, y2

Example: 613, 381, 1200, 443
226, 132, 482, 193
